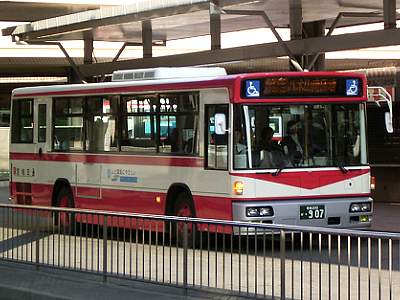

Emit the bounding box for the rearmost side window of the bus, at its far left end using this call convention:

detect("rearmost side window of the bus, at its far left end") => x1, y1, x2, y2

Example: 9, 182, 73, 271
11, 99, 33, 144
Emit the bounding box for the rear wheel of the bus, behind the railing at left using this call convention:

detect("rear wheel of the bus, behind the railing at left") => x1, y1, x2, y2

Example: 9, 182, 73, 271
54, 186, 75, 234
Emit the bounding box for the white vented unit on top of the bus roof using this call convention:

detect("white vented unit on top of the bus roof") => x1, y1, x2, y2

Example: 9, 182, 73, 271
112, 67, 226, 81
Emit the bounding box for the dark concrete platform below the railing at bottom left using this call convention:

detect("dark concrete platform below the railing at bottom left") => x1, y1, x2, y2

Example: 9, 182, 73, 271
0, 261, 216, 300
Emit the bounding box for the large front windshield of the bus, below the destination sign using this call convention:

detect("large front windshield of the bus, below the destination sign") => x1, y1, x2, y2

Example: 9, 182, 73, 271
233, 103, 367, 170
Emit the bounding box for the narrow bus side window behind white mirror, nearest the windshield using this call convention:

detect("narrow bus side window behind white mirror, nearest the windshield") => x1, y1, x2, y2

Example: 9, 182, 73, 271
205, 105, 229, 170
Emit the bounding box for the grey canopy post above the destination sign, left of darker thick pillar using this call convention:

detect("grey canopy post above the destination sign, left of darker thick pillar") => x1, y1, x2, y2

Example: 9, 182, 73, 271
289, 0, 304, 71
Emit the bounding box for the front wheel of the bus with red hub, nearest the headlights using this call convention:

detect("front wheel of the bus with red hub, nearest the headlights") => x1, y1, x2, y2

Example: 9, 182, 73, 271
171, 192, 199, 248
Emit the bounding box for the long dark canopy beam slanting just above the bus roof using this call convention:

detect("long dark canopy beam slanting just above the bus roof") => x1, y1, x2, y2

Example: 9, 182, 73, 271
79, 28, 400, 77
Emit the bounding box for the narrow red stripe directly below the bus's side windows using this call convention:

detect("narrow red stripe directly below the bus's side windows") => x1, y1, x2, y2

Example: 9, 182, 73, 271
10, 152, 204, 168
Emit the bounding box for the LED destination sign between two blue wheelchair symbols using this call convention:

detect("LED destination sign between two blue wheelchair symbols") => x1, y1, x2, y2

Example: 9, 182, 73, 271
242, 76, 362, 98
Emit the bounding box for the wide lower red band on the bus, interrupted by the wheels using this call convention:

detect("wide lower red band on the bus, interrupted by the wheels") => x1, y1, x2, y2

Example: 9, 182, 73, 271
10, 182, 370, 220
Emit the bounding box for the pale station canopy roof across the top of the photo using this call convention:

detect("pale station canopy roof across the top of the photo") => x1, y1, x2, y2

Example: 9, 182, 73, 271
3, 0, 400, 43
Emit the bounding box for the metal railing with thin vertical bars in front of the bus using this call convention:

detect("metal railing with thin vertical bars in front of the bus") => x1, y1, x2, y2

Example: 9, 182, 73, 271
0, 204, 400, 299
